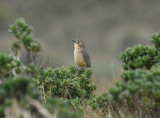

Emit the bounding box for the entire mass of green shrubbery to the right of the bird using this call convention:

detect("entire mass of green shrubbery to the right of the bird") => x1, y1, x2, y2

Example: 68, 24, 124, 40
95, 33, 160, 118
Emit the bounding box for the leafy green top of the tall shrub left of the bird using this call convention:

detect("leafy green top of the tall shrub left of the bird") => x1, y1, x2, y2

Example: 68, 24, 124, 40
9, 18, 41, 53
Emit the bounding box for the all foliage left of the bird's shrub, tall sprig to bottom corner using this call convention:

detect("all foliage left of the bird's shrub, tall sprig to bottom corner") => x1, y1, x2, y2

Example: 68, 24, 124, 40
0, 18, 82, 118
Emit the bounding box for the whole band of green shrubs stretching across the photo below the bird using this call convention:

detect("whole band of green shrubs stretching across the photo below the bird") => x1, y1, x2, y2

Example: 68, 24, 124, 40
0, 18, 160, 118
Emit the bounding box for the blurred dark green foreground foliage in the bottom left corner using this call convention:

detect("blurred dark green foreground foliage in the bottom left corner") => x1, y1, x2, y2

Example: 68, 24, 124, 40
0, 77, 81, 118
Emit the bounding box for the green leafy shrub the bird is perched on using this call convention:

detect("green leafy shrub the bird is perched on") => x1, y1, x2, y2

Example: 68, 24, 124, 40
35, 65, 96, 99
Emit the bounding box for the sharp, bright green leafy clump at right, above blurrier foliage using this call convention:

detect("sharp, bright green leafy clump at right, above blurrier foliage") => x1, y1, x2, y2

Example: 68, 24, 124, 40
121, 45, 160, 70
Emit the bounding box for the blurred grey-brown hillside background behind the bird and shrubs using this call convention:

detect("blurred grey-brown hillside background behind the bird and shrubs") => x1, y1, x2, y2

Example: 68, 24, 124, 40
0, 0, 160, 88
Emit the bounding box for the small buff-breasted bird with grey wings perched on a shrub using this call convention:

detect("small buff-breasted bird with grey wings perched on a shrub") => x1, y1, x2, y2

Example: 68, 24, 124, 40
72, 40, 91, 68
